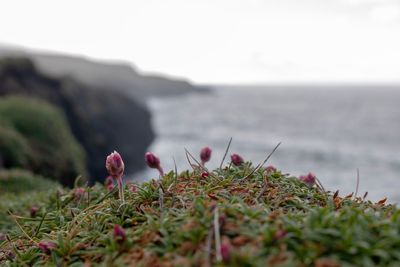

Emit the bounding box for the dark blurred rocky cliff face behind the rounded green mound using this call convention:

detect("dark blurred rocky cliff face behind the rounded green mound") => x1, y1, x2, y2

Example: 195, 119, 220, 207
0, 57, 154, 184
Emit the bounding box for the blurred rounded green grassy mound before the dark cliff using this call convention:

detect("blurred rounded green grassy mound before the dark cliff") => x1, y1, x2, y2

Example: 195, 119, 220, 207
0, 97, 85, 184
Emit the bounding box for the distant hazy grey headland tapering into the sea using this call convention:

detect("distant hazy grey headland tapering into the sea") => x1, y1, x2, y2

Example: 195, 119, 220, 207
0, 48, 202, 100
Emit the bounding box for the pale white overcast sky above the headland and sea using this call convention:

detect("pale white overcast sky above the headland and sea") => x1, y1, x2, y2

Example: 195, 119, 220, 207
0, 0, 400, 84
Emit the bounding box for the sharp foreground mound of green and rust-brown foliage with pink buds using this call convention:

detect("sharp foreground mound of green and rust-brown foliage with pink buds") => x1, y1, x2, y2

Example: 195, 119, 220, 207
0, 163, 400, 267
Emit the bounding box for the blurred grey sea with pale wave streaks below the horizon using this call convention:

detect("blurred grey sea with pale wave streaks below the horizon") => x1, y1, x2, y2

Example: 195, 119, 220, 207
135, 85, 400, 203
